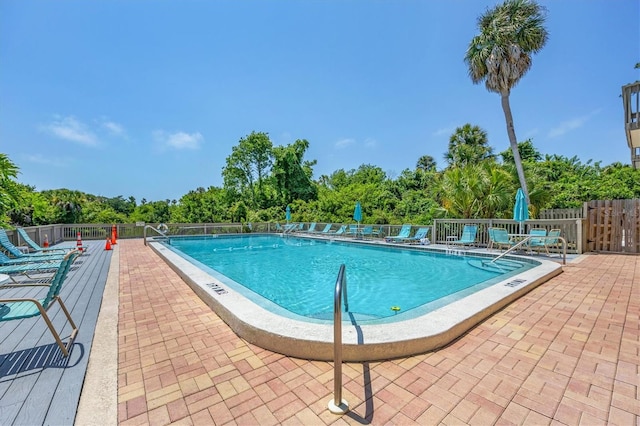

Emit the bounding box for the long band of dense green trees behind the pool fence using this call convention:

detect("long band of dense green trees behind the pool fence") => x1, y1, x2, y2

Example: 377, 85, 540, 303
0, 123, 640, 227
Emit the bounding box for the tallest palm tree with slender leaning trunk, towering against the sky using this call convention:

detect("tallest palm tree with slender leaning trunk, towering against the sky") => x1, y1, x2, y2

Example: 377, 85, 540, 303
464, 0, 549, 202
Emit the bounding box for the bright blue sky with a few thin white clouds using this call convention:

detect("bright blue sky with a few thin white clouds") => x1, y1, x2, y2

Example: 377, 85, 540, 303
0, 0, 640, 202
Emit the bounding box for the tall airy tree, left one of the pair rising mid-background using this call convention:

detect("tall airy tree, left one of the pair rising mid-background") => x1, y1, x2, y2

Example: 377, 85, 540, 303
222, 132, 273, 208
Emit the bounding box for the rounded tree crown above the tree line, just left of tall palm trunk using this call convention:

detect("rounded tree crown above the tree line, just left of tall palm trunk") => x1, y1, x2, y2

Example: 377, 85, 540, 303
444, 123, 494, 167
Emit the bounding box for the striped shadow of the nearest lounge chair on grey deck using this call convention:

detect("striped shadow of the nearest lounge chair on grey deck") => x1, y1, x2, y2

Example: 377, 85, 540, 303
0, 343, 84, 382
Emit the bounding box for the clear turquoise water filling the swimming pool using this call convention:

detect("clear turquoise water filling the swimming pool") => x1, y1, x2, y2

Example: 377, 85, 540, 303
165, 235, 535, 322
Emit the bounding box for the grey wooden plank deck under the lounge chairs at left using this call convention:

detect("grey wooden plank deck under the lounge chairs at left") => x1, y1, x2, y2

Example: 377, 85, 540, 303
0, 241, 112, 425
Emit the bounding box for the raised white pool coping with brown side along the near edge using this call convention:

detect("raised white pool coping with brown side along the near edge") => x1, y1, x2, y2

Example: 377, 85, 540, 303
148, 241, 562, 362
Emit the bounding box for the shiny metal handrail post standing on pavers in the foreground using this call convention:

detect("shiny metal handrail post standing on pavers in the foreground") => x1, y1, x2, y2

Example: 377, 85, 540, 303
328, 263, 349, 414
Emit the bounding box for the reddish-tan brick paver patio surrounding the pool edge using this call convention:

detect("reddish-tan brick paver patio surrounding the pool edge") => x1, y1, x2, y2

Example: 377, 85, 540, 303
118, 240, 640, 425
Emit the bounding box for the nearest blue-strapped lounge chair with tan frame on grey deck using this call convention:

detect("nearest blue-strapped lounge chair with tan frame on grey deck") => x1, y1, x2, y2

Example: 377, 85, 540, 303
0, 250, 80, 357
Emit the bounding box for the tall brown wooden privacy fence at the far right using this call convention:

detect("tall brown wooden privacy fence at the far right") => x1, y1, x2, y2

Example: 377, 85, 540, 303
584, 198, 640, 254
